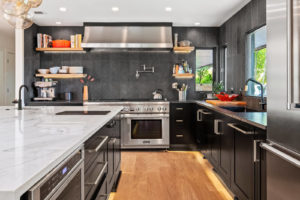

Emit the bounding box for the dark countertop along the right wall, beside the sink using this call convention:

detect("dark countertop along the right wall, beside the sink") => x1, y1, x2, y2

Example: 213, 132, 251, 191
194, 101, 267, 130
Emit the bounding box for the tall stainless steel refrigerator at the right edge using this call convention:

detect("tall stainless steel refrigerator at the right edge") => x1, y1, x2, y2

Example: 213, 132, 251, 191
261, 0, 300, 200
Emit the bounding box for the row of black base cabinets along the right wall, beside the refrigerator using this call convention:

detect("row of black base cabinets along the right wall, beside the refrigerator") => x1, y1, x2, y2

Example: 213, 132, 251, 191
194, 105, 266, 200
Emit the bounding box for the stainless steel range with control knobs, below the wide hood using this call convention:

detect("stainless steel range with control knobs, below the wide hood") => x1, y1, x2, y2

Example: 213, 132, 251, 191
85, 101, 170, 149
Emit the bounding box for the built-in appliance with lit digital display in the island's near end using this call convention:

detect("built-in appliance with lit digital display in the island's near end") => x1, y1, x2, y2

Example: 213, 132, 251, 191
27, 147, 84, 200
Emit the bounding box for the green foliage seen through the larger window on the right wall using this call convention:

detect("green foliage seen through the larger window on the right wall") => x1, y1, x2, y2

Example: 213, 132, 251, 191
254, 48, 267, 86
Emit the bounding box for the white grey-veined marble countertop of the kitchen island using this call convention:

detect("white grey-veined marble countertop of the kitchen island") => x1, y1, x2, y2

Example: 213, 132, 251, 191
0, 106, 123, 200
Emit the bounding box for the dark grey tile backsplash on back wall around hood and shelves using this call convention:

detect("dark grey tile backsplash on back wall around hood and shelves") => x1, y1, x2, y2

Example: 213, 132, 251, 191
25, 25, 219, 101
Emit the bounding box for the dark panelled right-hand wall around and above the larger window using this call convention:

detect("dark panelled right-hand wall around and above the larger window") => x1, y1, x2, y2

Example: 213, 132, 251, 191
219, 0, 266, 91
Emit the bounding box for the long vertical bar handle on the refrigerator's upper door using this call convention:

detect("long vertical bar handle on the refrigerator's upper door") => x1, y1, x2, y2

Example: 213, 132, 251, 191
287, 0, 293, 110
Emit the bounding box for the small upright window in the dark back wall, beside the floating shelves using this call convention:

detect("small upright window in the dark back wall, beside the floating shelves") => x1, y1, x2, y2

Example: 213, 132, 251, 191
195, 49, 214, 91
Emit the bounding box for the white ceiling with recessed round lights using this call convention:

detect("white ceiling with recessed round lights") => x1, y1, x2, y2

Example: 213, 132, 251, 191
33, 0, 250, 26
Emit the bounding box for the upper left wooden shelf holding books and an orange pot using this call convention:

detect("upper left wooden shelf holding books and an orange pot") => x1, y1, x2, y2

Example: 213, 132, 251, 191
36, 33, 86, 53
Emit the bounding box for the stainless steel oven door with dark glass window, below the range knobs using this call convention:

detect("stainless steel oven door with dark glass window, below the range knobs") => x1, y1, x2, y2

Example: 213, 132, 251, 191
121, 114, 170, 149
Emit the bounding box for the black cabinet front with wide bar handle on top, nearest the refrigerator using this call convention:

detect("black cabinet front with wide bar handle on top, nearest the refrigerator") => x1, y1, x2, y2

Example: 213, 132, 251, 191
229, 123, 255, 200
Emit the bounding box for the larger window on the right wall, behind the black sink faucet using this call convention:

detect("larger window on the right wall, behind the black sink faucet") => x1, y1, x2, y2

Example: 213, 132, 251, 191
246, 26, 267, 96
